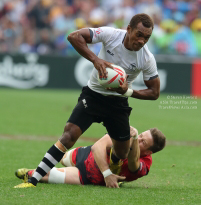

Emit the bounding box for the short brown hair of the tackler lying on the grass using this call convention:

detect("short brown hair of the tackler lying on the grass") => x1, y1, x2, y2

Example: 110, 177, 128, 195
149, 128, 166, 153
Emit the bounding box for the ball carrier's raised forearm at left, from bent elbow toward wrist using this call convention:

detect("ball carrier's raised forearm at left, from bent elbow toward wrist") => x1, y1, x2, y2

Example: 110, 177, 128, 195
68, 31, 98, 63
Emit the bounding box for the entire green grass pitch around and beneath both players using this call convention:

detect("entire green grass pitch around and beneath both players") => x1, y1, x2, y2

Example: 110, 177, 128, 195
0, 89, 201, 205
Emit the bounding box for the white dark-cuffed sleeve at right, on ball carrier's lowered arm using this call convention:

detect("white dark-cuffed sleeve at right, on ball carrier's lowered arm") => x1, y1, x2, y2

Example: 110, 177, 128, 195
143, 56, 158, 81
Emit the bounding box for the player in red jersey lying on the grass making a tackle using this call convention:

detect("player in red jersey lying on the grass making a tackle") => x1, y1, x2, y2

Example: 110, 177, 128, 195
13, 127, 166, 188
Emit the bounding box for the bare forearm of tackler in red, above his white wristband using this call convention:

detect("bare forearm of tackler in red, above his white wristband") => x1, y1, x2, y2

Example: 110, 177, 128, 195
91, 144, 109, 172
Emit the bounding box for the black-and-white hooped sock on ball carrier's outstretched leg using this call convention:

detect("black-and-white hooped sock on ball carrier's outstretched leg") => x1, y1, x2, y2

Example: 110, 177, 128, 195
28, 145, 65, 186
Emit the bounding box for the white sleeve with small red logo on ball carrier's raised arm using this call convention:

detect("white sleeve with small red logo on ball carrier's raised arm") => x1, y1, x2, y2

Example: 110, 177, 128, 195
89, 27, 115, 44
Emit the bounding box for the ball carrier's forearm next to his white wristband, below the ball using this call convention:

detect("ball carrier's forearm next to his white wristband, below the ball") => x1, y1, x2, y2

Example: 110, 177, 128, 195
131, 89, 160, 100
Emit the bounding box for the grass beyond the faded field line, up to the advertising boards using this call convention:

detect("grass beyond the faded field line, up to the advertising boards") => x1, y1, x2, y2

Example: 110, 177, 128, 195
0, 89, 201, 141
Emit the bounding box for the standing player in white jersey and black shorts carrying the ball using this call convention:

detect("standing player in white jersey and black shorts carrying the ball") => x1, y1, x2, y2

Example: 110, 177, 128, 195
13, 14, 160, 188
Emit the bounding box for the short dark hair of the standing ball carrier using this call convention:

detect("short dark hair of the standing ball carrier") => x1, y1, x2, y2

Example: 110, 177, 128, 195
129, 13, 154, 30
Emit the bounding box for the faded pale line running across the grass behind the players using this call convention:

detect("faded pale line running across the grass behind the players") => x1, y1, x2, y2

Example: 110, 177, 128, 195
0, 135, 201, 147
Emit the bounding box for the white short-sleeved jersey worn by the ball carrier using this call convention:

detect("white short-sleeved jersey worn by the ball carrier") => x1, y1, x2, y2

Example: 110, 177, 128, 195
88, 27, 158, 96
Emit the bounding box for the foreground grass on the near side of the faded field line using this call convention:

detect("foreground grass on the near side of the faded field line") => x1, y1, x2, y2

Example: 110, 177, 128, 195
0, 139, 201, 205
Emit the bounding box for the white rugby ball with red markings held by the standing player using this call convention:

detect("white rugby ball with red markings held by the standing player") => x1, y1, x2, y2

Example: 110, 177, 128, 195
98, 64, 126, 88
